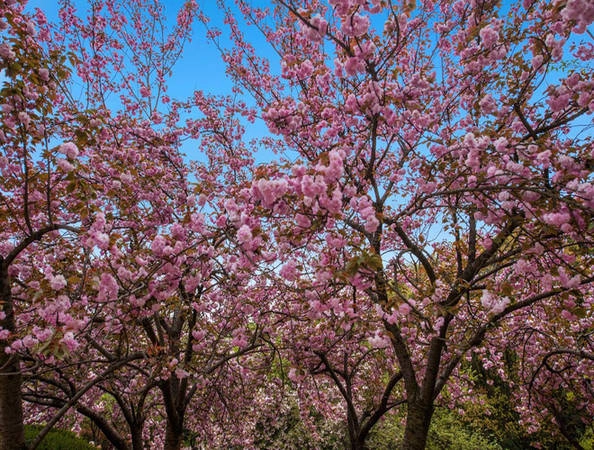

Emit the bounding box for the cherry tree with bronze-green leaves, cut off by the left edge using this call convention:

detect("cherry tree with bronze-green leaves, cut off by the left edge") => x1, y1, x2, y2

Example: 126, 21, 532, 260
0, 2, 99, 449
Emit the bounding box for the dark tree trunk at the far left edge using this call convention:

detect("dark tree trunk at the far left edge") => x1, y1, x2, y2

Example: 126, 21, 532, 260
0, 264, 25, 450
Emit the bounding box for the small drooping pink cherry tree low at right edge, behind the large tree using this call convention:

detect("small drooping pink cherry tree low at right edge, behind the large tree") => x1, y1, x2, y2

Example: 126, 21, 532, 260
485, 278, 593, 442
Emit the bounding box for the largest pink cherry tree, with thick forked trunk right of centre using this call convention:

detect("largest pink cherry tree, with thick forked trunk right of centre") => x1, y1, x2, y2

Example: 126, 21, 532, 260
210, 0, 594, 449
